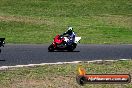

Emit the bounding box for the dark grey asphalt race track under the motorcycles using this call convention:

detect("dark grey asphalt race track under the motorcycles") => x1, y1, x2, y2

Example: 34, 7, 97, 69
0, 44, 132, 66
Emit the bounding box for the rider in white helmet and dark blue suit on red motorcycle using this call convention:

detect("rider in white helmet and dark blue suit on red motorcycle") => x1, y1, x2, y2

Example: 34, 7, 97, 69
63, 27, 76, 45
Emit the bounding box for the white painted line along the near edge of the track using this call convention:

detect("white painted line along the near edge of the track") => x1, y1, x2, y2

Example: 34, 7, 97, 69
0, 59, 132, 70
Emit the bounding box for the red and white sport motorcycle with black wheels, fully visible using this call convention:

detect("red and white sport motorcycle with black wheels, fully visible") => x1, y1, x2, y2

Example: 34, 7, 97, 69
48, 35, 81, 52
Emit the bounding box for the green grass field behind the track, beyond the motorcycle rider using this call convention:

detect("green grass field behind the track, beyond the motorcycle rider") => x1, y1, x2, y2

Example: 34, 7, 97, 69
0, 0, 132, 44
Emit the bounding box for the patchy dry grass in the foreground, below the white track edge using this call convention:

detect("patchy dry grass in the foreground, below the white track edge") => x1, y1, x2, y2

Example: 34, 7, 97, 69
0, 60, 132, 88
